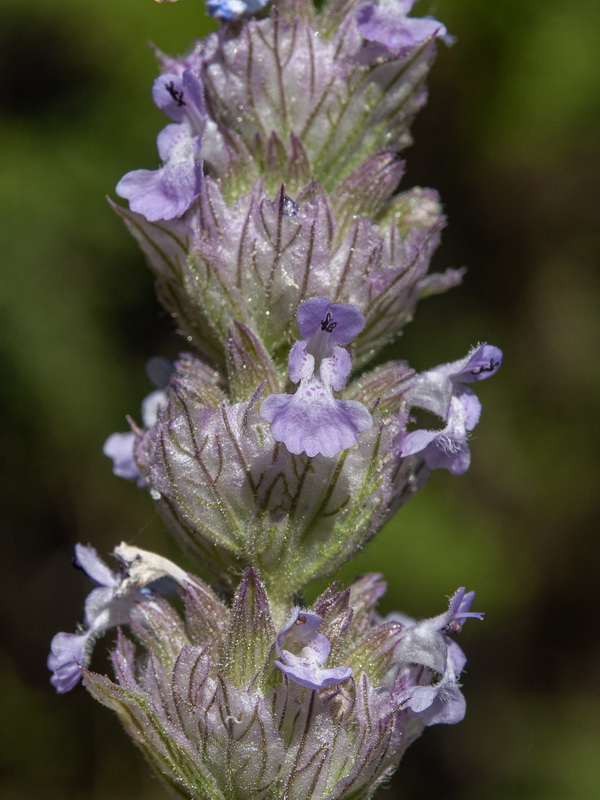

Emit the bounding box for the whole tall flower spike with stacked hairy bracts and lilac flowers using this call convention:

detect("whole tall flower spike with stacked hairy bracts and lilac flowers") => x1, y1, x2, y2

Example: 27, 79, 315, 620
48, 0, 502, 800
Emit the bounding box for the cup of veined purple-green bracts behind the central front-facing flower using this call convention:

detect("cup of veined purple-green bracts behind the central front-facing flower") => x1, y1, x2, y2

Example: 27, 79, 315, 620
135, 354, 424, 600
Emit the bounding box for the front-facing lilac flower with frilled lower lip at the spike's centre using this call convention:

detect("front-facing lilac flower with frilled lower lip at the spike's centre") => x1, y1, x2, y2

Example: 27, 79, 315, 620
260, 297, 373, 457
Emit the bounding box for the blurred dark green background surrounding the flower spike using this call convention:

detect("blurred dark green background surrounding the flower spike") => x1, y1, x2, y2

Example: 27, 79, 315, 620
0, 0, 600, 800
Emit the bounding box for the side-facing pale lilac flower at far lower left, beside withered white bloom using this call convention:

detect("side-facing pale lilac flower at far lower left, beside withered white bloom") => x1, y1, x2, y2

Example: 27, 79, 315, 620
47, 544, 143, 694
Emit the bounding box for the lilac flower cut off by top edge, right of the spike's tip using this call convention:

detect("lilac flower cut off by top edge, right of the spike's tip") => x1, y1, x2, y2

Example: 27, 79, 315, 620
356, 0, 453, 50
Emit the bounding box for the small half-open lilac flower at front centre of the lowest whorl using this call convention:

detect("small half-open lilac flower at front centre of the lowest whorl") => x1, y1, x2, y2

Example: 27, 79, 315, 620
275, 606, 352, 689
